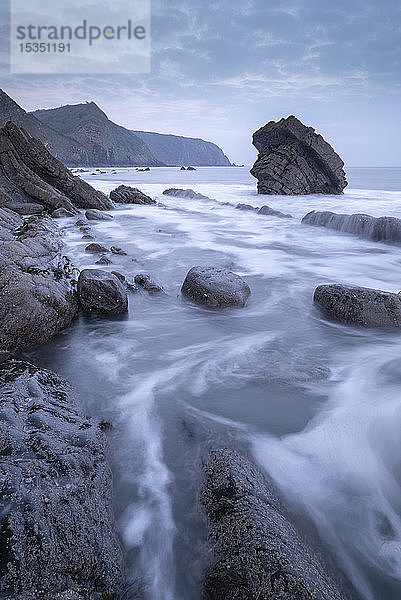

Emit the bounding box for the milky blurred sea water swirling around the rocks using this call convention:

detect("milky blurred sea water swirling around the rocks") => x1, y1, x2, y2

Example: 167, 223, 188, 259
32, 168, 401, 600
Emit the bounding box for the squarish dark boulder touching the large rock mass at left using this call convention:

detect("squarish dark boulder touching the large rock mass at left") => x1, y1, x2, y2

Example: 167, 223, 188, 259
78, 269, 128, 314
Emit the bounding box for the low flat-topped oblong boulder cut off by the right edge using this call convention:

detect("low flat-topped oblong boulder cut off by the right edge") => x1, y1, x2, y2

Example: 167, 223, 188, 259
313, 284, 401, 327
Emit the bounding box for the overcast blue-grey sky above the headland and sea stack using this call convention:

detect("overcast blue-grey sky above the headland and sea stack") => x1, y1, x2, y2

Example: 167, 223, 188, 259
0, 0, 401, 166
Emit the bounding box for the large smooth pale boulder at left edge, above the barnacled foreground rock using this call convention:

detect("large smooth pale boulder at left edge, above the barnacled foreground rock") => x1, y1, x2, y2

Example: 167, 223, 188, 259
0, 217, 78, 350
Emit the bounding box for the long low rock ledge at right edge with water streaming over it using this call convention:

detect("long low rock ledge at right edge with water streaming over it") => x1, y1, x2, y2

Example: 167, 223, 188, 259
302, 210, 401, 244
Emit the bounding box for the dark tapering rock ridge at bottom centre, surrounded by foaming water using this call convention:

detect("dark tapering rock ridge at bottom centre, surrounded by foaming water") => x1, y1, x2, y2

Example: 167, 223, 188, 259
201, 449, 347, 600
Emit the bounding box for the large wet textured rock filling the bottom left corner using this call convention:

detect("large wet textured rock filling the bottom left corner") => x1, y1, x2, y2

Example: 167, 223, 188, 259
0, 357, 123, 600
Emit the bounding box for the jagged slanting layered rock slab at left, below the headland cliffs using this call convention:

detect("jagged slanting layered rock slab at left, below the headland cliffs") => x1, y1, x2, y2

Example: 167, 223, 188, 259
0, 121, 111, 212
